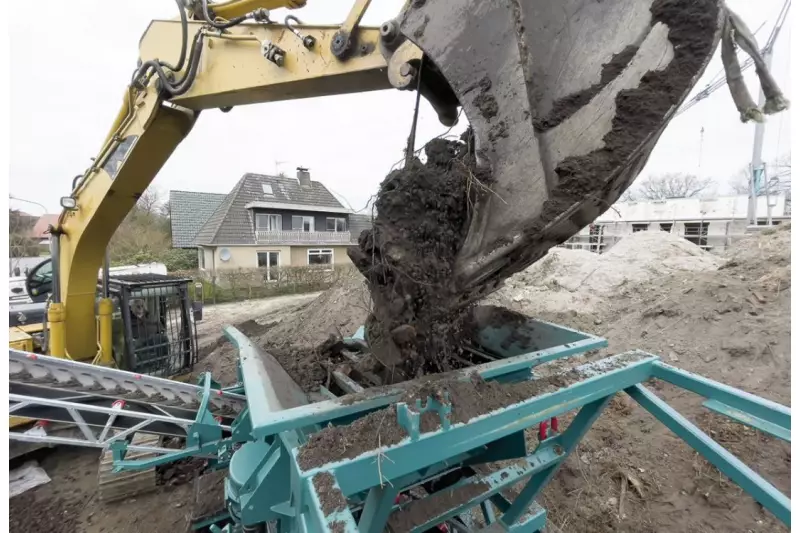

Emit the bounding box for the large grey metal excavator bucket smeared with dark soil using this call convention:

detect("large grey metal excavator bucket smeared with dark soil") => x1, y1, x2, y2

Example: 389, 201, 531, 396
399, 0, 727, 291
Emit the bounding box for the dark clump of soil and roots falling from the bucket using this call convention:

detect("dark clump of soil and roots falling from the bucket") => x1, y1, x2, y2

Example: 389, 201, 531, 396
349, 135, 489, 381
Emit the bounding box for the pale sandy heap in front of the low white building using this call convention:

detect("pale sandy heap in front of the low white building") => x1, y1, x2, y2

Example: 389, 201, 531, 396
488, 231, 725, 317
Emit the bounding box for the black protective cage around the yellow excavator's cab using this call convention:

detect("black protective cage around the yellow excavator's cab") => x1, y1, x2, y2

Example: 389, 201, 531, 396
109, 274, 197, 377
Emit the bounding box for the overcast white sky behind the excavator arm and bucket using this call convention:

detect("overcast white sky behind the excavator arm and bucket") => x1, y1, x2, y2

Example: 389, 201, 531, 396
9, 0, 794, 214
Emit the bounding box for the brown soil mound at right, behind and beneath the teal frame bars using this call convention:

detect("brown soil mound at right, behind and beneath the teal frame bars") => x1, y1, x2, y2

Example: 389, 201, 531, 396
540, 226, 791, 533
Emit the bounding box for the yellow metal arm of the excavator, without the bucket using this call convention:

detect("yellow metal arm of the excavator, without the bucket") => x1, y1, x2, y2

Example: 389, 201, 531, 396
53, 13, 421, 359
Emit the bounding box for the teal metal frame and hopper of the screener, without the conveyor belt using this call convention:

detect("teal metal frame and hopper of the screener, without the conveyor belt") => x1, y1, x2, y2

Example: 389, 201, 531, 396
108, 314, 791, 533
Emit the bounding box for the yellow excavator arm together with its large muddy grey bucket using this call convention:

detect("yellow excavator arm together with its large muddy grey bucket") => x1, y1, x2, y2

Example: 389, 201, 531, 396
50, 0, 780, 357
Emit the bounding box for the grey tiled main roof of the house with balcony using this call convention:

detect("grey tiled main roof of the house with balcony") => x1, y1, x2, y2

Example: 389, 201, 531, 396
195, 173, 344, 245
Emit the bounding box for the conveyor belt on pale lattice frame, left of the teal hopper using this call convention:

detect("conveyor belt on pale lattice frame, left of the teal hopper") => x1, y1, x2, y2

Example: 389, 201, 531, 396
9, 350, 246, 453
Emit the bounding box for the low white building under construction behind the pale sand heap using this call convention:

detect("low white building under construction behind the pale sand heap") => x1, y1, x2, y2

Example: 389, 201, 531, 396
562, 193, 791, 253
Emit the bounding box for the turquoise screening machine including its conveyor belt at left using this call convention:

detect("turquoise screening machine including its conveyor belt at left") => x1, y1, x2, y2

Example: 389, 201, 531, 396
10, 306, 791, 533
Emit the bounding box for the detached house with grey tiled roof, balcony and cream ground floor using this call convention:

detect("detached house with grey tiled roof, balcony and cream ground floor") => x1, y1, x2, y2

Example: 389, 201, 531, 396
170, 168, 371, 277
